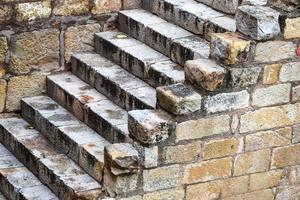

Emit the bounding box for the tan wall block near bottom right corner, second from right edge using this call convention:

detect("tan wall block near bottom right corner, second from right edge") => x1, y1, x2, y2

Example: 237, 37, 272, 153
249, 170, 285, 190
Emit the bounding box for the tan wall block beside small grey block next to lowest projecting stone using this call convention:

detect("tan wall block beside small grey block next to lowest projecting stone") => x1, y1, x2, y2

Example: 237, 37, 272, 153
163, 142, 201, 164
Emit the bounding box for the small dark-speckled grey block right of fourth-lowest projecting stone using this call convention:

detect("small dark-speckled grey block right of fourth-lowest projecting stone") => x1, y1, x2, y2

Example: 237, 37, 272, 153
228, 67, 261, 88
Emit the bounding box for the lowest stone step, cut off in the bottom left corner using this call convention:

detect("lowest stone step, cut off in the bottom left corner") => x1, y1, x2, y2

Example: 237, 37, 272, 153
0, 142, 58, 200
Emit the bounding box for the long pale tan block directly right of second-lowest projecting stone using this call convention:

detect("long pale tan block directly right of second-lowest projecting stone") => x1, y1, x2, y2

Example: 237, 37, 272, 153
175, 115, 230, 141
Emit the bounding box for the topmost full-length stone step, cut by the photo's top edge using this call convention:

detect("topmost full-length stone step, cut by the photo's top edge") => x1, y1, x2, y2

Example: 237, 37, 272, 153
142, 0, 236, 39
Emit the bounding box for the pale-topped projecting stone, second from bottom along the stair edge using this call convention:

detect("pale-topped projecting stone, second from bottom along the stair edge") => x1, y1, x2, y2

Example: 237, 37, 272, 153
128, 110, 171, 144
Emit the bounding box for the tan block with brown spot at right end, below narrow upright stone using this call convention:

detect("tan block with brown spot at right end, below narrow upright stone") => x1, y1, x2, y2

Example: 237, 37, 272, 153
203, 138, 243, 159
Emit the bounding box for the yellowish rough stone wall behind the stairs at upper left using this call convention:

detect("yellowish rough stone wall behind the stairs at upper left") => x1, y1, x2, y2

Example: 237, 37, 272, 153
0, 0, 139, 113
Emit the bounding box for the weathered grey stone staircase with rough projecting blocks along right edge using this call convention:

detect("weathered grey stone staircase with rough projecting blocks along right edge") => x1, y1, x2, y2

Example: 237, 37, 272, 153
0, 0, 290, 200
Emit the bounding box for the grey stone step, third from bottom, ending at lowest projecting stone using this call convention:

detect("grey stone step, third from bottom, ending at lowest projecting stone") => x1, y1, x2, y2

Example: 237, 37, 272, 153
21, 96, 110, 182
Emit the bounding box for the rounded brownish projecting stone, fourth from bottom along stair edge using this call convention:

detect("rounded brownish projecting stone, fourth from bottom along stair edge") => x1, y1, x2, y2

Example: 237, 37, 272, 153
184, 59, 226, 91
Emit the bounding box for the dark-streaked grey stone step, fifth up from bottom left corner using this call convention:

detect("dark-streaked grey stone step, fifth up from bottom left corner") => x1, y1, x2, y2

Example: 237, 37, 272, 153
72, 50, 159, 110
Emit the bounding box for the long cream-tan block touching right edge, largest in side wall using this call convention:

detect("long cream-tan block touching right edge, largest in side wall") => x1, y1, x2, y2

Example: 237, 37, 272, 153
240, 103, 300, 133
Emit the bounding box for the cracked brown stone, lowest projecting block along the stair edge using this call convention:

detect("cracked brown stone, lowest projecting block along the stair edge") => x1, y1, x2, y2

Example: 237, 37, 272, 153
104, 143, 139, 176
